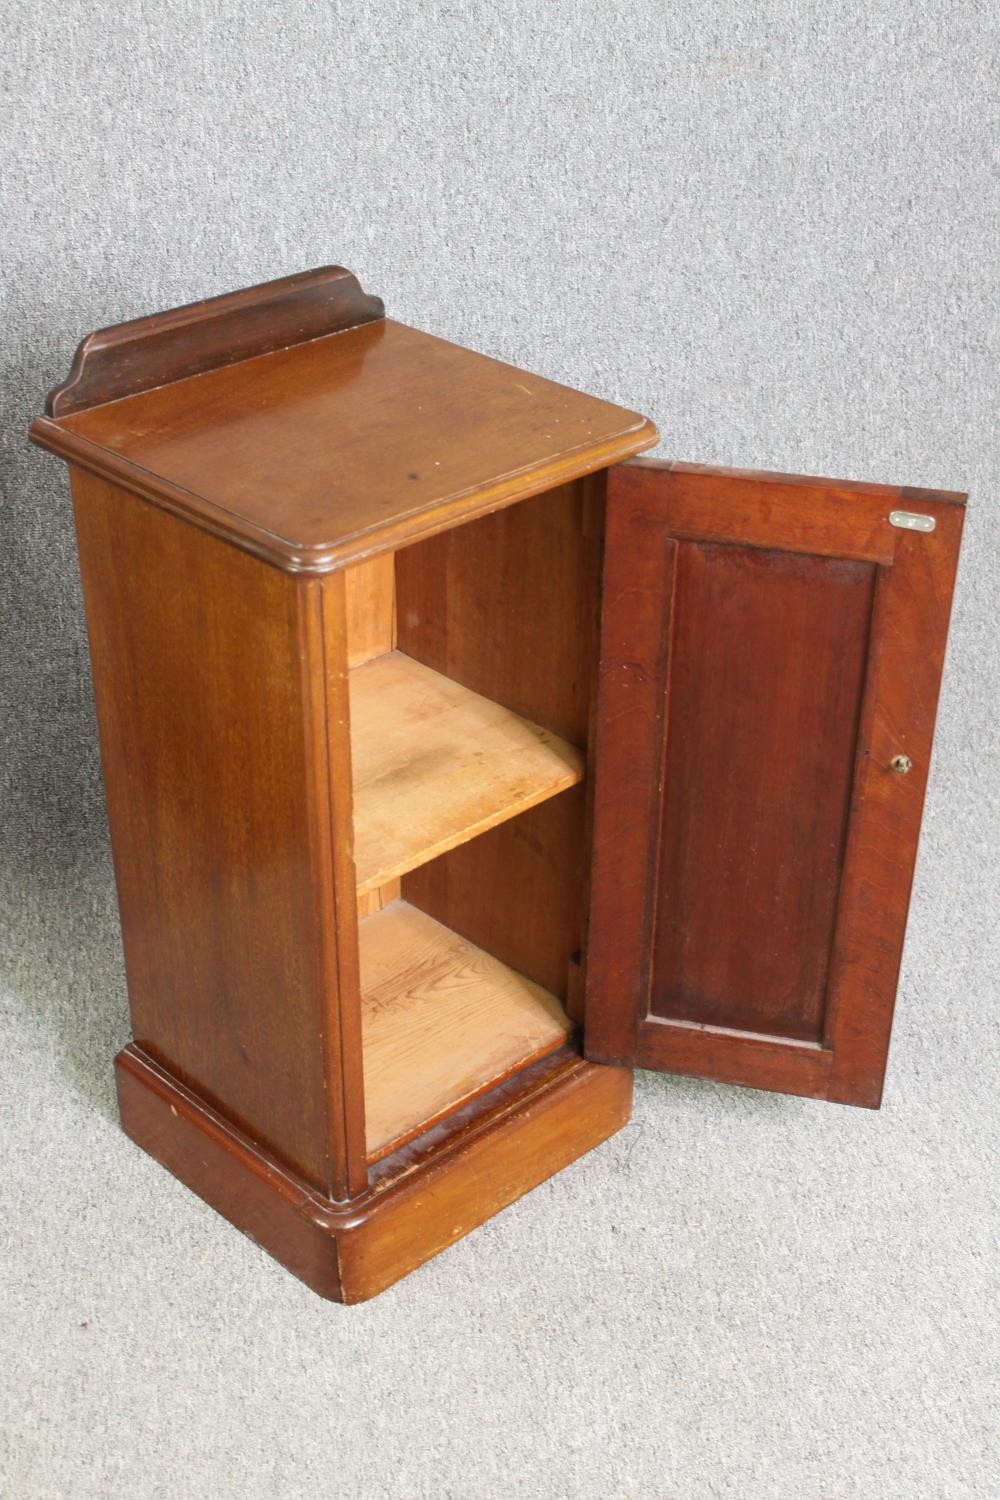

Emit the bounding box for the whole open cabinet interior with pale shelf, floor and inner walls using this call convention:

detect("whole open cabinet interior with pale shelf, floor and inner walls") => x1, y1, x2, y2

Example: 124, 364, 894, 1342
345, 480, 601, 1161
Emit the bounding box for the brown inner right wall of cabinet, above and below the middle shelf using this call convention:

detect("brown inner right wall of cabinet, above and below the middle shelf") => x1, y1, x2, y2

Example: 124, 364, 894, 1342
396, 476, 603, 999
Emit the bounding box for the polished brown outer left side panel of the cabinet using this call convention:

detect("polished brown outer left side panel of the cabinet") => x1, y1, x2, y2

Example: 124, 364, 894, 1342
72, 473, 338, 1188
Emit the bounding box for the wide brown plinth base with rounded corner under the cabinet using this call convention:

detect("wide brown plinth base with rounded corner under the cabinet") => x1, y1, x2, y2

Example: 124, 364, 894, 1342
115, 1046, 631, 1302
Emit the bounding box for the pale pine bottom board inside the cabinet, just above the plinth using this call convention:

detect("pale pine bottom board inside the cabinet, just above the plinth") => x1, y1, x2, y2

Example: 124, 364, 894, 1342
360, 902, 573, 1160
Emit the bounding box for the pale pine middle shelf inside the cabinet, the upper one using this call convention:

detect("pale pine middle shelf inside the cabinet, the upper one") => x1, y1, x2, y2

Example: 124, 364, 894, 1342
351, 651, 583, 896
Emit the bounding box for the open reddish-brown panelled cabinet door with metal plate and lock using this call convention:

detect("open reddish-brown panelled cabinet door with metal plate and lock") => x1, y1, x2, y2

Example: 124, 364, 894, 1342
585, 459, 966, 1109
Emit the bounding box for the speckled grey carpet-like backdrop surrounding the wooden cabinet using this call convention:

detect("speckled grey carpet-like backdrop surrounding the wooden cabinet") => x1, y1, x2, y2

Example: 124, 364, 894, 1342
0, 0, 1000, 1500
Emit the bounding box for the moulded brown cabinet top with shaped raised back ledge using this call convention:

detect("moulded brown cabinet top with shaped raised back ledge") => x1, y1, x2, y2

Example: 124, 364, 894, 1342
31, 267, 657, 572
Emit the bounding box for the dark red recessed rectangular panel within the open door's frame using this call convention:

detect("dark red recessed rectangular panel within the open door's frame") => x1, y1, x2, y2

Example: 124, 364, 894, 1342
649, 542, 876, 1041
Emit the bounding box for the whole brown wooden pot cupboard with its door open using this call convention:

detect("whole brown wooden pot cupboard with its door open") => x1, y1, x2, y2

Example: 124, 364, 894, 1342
31, 267, 964, 1302
